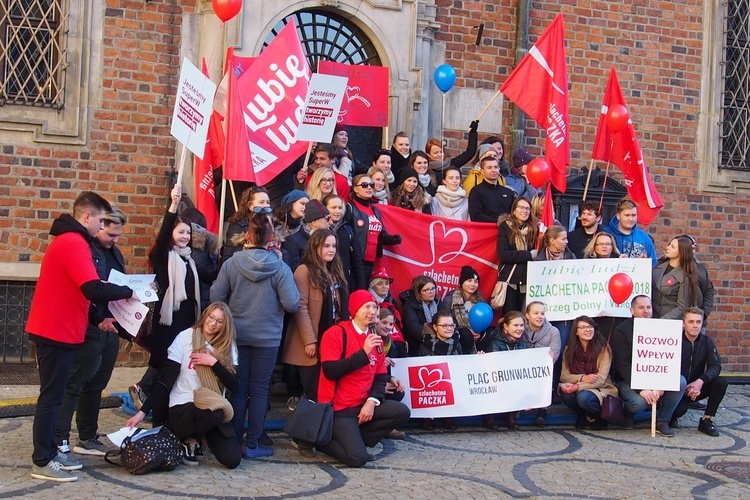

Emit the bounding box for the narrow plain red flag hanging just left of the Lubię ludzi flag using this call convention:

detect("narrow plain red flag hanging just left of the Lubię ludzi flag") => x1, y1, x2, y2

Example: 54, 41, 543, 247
222, 67, 255, 182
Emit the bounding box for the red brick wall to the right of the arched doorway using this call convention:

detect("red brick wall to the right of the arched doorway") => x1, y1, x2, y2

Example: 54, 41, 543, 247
436, 0, 750, 372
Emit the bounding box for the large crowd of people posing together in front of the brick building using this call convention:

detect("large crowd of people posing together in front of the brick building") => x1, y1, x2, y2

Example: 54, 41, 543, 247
27, 127, 727, 481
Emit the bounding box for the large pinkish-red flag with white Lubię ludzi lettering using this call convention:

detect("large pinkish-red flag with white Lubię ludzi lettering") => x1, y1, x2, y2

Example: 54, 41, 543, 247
235, 22, 312, 185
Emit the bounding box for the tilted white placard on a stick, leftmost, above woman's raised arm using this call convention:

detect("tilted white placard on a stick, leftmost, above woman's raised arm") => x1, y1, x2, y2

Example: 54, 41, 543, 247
169, 58, 216, 159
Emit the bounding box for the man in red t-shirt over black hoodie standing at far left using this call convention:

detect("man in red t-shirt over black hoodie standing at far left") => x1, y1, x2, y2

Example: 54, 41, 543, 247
26, 191, 136, 482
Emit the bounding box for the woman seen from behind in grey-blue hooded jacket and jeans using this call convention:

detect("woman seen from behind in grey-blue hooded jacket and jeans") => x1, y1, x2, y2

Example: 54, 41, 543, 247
211, 213, 299, 458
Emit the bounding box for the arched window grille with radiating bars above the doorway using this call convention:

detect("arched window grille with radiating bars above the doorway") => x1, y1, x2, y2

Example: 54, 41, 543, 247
263, 10, 381, 71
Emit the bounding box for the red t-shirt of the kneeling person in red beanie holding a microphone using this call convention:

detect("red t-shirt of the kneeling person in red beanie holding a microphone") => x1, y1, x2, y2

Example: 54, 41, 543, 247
318, 321, 388, 411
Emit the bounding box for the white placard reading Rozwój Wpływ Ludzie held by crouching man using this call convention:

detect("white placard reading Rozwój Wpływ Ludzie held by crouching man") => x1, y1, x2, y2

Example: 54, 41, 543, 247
630, 318, 682, 391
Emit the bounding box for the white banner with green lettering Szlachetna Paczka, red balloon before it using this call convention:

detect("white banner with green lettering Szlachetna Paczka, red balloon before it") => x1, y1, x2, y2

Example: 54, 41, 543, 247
526, 259, 652, 321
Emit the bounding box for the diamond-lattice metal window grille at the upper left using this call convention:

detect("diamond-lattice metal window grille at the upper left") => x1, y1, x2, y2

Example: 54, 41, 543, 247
0, 0, 69, 109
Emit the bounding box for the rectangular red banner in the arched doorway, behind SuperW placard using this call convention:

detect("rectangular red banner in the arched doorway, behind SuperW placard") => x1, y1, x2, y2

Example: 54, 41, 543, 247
318, 61, 390, 127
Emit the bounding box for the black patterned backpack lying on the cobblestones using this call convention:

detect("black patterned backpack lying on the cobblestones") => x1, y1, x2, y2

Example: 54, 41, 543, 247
104, 426, 182, 476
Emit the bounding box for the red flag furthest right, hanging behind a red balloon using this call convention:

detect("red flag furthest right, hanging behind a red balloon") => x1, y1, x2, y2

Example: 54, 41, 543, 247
591, 67, 664, 226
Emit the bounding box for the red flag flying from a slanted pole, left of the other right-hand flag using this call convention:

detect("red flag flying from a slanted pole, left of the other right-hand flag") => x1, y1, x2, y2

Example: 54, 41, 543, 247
500, 14, 570, 193
